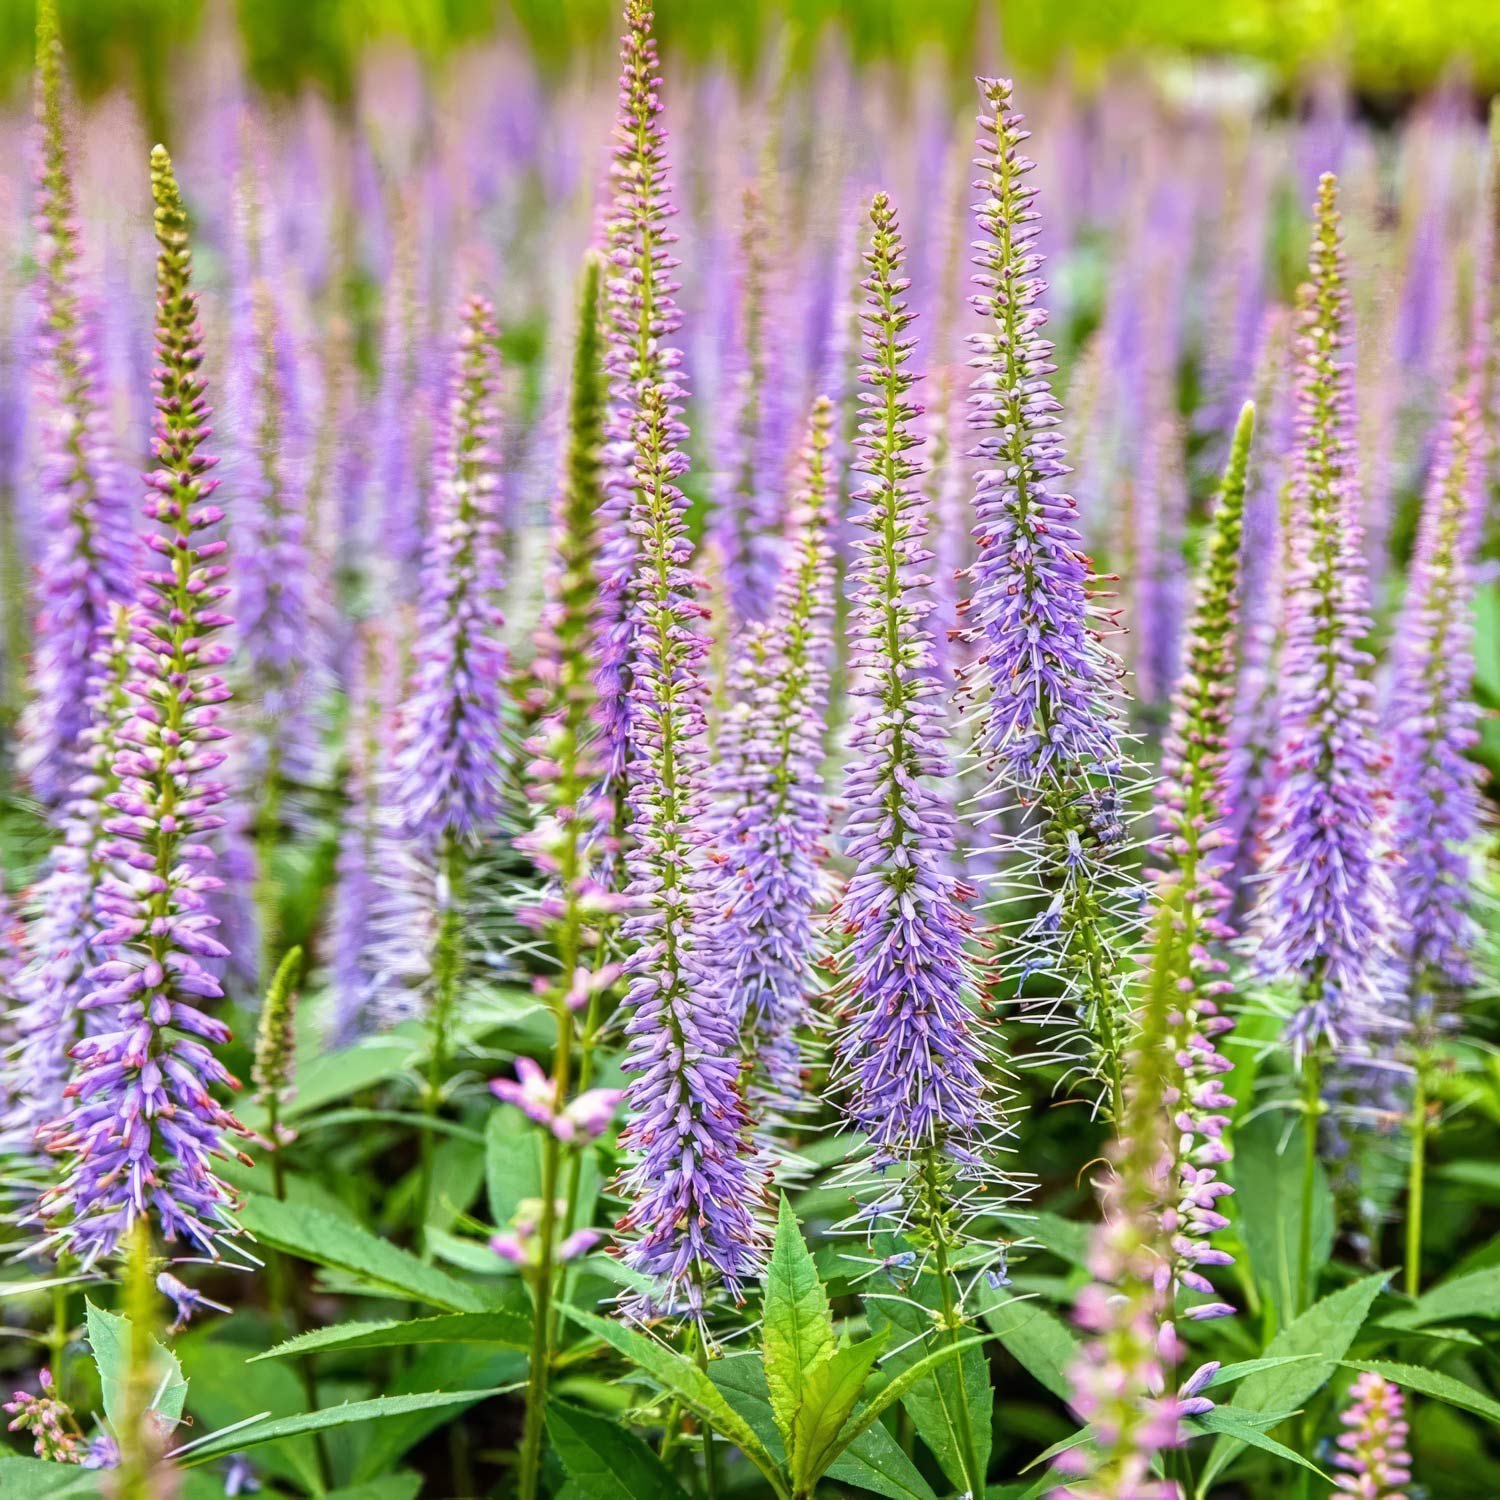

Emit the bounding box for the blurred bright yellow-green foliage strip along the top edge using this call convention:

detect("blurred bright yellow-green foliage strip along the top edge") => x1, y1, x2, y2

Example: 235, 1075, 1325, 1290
0, 0, 1500, 140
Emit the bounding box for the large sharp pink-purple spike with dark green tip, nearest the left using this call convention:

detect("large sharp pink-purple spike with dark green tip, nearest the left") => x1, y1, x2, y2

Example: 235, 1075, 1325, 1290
42, 146, 243, 1265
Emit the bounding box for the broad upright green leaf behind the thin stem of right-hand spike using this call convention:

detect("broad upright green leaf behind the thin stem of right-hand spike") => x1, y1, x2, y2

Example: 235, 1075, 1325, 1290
1230, 1115, 1334, 1326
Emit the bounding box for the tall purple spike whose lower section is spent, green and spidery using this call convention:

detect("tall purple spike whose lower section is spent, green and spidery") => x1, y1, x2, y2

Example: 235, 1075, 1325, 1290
965, 78, 1131, 1112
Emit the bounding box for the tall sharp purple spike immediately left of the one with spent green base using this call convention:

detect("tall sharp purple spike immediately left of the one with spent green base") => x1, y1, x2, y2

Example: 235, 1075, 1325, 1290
836, 194, 990, 1161
